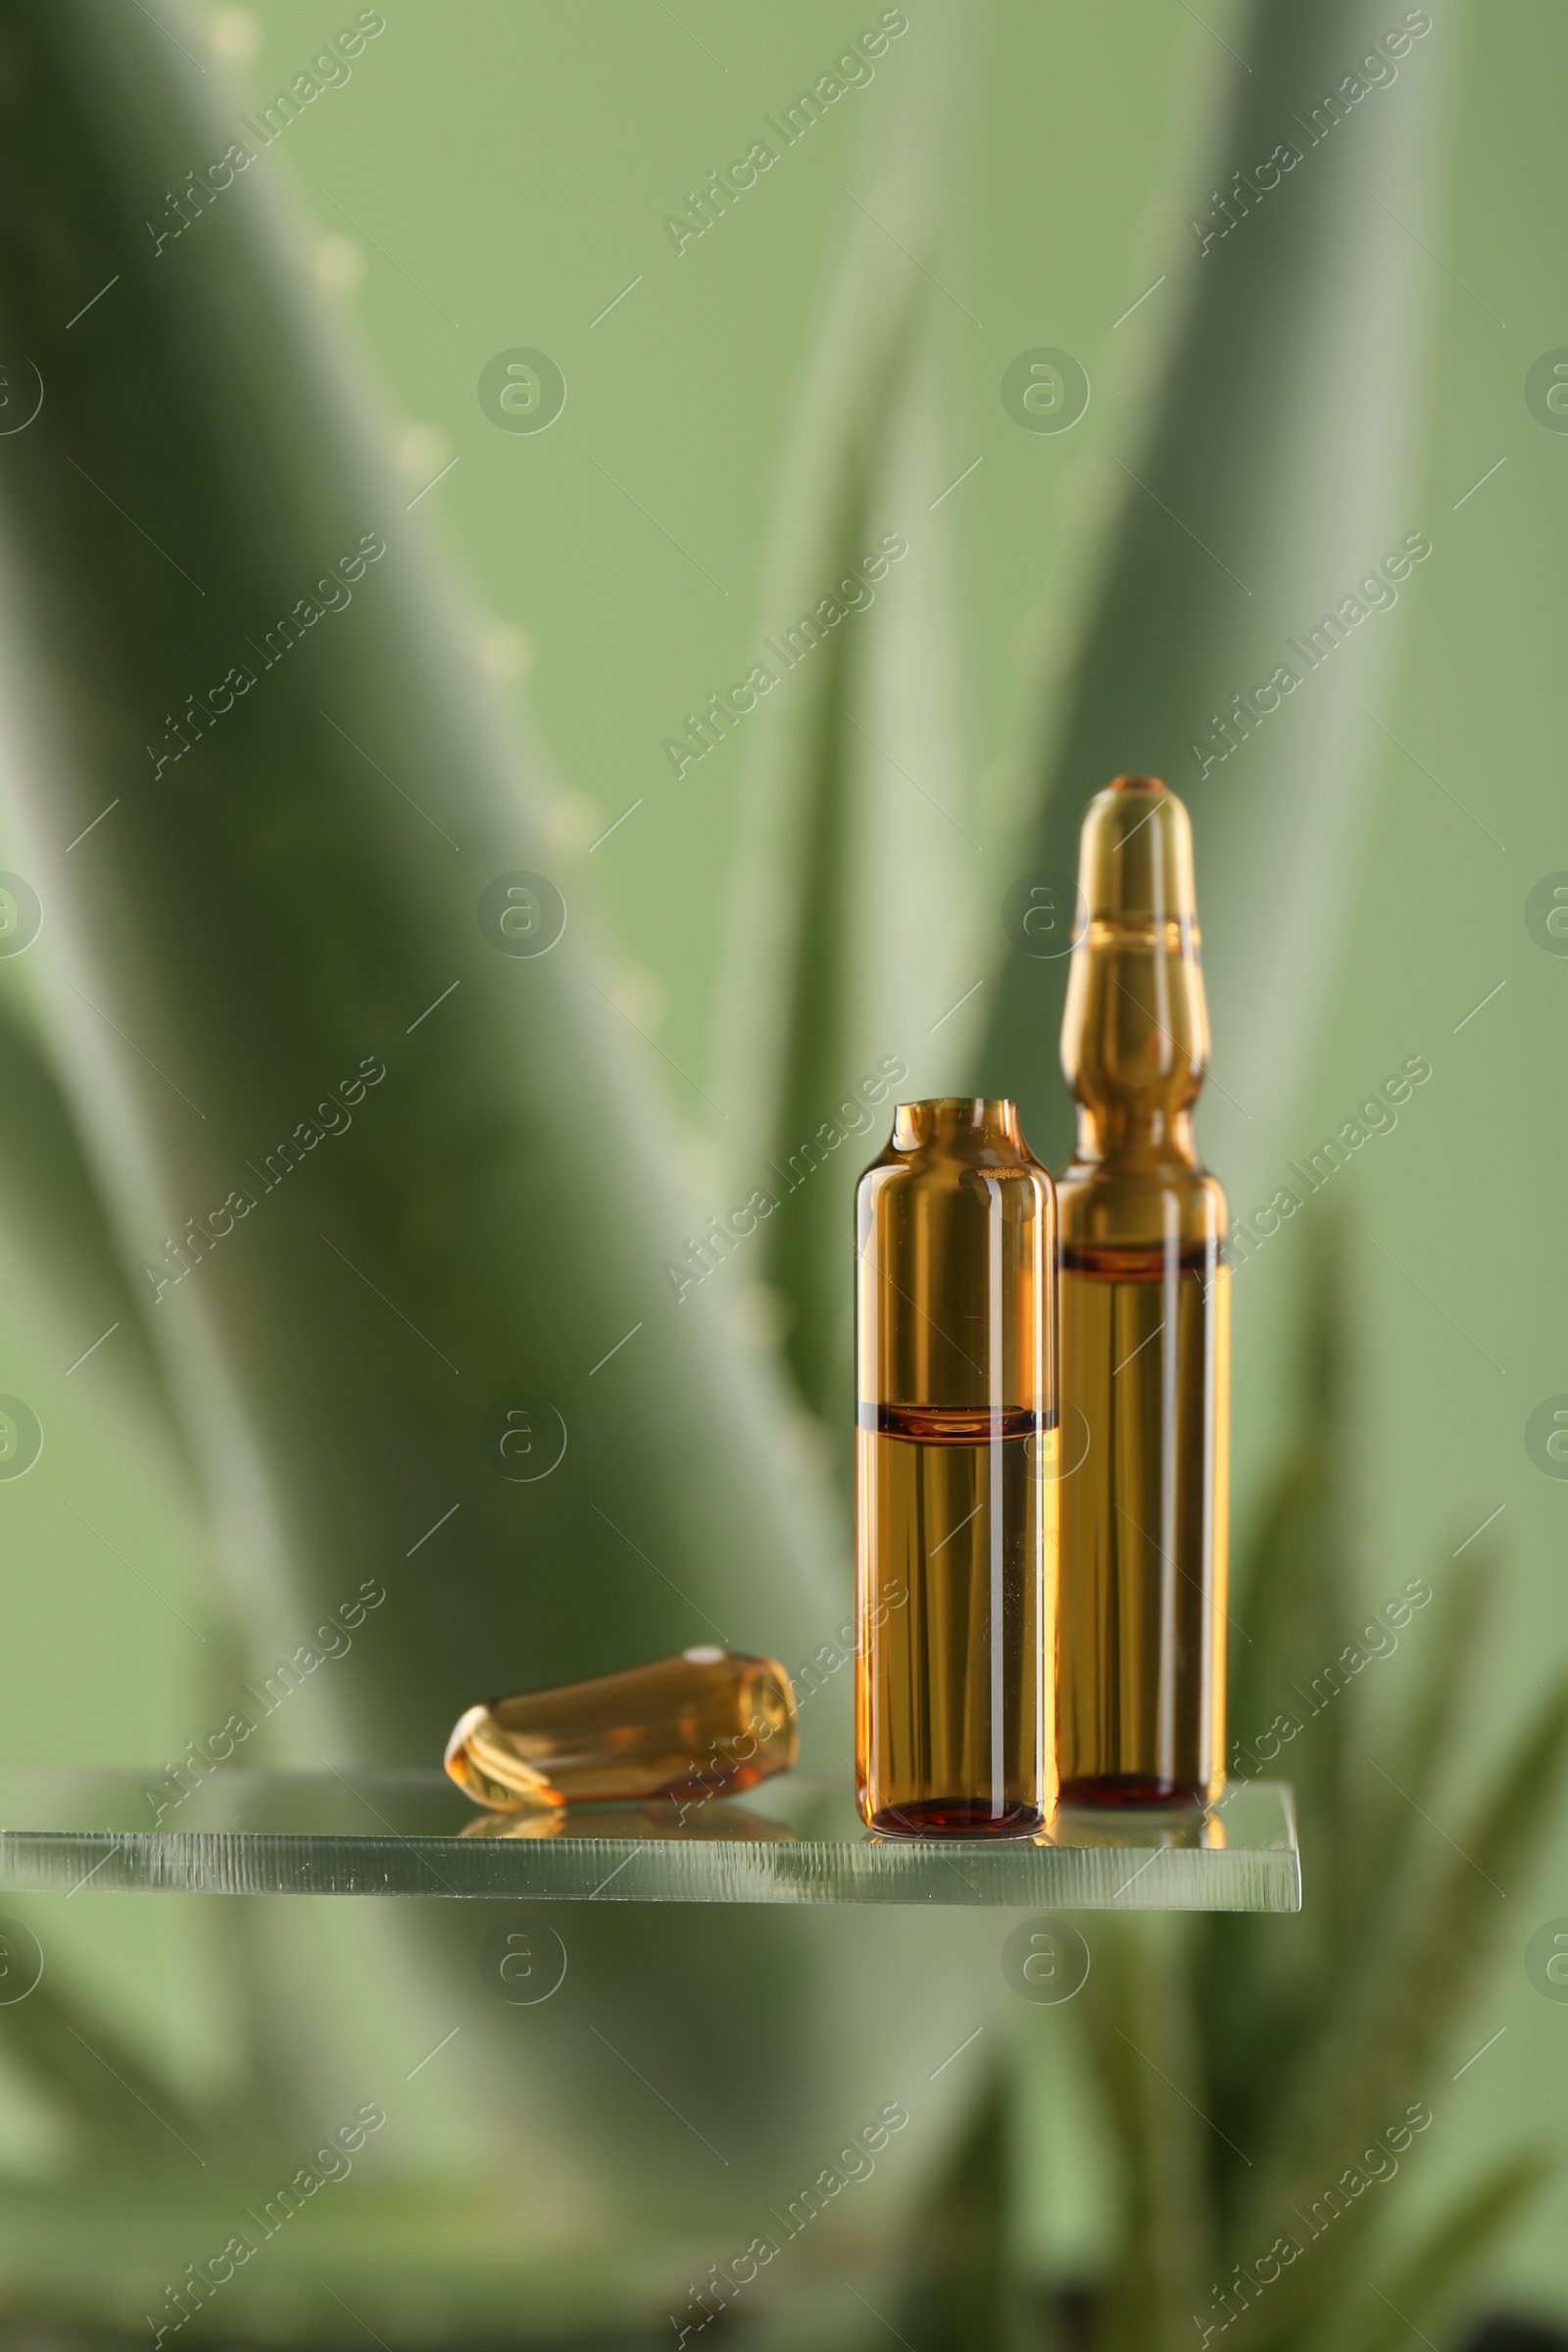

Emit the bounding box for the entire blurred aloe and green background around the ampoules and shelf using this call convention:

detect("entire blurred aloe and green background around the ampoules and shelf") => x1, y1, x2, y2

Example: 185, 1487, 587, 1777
0, 0, 1568, 2352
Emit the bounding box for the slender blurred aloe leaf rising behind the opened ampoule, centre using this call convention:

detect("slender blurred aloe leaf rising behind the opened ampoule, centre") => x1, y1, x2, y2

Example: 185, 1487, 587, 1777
719, 10, 971, 1423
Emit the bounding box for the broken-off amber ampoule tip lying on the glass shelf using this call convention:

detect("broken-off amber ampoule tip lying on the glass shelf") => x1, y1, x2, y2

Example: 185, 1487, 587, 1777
447, 1648, 797, 1813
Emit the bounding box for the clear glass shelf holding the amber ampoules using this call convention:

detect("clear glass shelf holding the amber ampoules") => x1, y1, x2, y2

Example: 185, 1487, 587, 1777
0, 1766, 1300, 1912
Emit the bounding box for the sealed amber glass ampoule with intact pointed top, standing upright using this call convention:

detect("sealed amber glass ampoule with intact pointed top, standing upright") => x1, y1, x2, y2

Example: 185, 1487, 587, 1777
1057, 776, 1230, 1804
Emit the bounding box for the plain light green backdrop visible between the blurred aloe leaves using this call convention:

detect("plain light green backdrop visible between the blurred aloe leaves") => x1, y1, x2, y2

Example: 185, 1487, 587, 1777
0, 0, 1568, 2300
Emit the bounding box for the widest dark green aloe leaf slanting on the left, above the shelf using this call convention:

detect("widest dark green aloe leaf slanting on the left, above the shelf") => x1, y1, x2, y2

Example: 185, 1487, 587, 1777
0, 0, 832, 1762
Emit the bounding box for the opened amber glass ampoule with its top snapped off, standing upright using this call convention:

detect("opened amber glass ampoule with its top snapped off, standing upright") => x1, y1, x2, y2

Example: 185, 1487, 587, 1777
856, 1096, 1055, 1837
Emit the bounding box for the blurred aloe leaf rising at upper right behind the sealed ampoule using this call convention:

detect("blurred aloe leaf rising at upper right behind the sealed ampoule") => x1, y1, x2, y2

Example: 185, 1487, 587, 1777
980, 0, 1460, 1209
